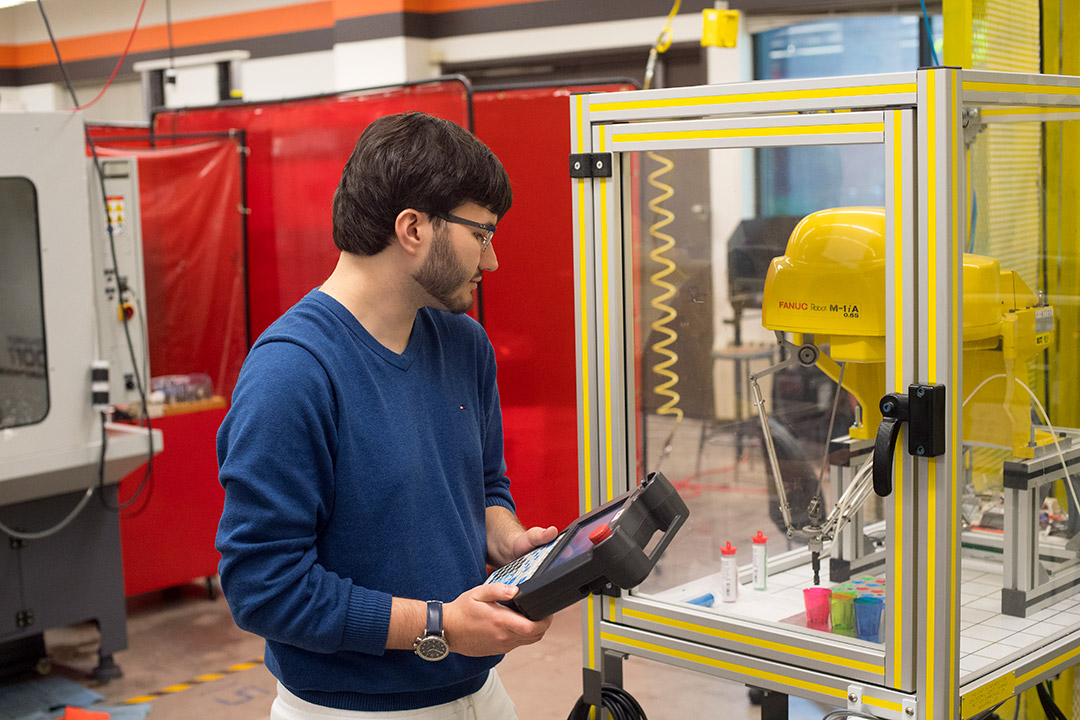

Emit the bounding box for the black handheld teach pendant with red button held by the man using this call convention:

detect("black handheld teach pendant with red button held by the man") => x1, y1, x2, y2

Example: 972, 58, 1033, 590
485, 473, 689, 620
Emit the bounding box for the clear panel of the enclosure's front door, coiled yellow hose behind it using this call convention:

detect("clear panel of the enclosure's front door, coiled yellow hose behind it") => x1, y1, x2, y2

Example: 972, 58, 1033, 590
623, 139, 887, 642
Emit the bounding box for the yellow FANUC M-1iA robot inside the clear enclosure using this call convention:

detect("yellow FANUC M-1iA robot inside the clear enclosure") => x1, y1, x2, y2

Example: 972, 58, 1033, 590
751, 207, 1075, 616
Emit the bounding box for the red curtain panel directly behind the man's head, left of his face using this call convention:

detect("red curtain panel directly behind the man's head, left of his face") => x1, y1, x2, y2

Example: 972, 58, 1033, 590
153, 80, 469, 340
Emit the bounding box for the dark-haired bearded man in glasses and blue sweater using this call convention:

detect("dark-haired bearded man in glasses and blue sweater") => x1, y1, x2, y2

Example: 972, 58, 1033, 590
217, 113, 556, 720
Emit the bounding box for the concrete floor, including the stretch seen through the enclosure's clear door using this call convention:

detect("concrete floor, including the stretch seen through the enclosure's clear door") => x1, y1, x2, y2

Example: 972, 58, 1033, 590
33, 410, 829, 720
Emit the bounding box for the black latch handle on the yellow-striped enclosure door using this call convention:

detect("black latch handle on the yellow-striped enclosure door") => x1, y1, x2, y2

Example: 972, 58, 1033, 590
873, 384, 945, 498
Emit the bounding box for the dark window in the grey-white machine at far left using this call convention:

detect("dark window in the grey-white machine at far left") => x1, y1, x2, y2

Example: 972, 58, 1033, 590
0, 177, 49, 429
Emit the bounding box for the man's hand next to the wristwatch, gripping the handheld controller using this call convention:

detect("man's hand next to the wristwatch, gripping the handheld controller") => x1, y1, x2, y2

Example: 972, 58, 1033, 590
443, 582, 554, 657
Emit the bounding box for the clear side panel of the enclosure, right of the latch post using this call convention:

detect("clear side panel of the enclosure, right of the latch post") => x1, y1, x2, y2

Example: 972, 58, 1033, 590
960, 117, 1080, 681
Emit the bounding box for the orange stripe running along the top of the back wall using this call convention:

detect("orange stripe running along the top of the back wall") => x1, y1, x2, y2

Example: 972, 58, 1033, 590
6, 0, 546, 68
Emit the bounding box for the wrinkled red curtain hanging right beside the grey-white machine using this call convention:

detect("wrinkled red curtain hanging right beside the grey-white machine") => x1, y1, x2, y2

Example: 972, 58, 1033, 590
95, 138, 247, 397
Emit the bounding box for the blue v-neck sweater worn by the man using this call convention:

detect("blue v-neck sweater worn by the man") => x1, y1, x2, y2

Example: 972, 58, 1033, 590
217, 290, 514, 710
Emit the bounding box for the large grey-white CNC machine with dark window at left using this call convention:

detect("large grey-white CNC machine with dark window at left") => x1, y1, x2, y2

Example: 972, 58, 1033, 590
0, 112, 162, 681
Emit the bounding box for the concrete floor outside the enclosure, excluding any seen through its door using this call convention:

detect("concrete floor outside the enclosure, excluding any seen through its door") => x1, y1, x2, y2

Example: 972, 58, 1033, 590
45, 583, 825, 720
